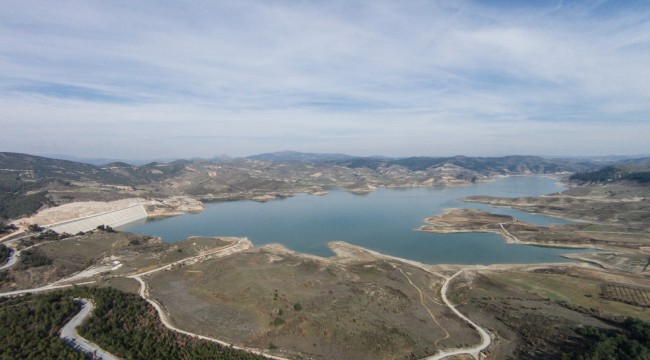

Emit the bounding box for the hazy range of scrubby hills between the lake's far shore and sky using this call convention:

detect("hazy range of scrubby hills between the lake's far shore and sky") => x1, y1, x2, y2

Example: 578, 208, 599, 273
0, 151, 612, 219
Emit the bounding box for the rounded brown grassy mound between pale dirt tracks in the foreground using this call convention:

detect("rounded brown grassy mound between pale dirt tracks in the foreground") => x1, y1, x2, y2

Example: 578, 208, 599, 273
146, 246, 480, 359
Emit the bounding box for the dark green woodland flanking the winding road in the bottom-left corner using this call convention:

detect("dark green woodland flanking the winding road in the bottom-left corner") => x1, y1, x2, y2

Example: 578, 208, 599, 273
0, 287, 264, 360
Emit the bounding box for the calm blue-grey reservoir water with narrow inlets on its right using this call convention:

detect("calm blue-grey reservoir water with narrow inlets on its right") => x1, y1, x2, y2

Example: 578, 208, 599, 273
120, 176, 585, 264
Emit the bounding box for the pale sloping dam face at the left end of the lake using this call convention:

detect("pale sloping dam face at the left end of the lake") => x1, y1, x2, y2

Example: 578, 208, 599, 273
46, 204, 147, 234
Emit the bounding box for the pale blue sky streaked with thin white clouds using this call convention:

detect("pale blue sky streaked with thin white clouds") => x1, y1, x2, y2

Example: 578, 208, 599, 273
0, 0, 650, 159
